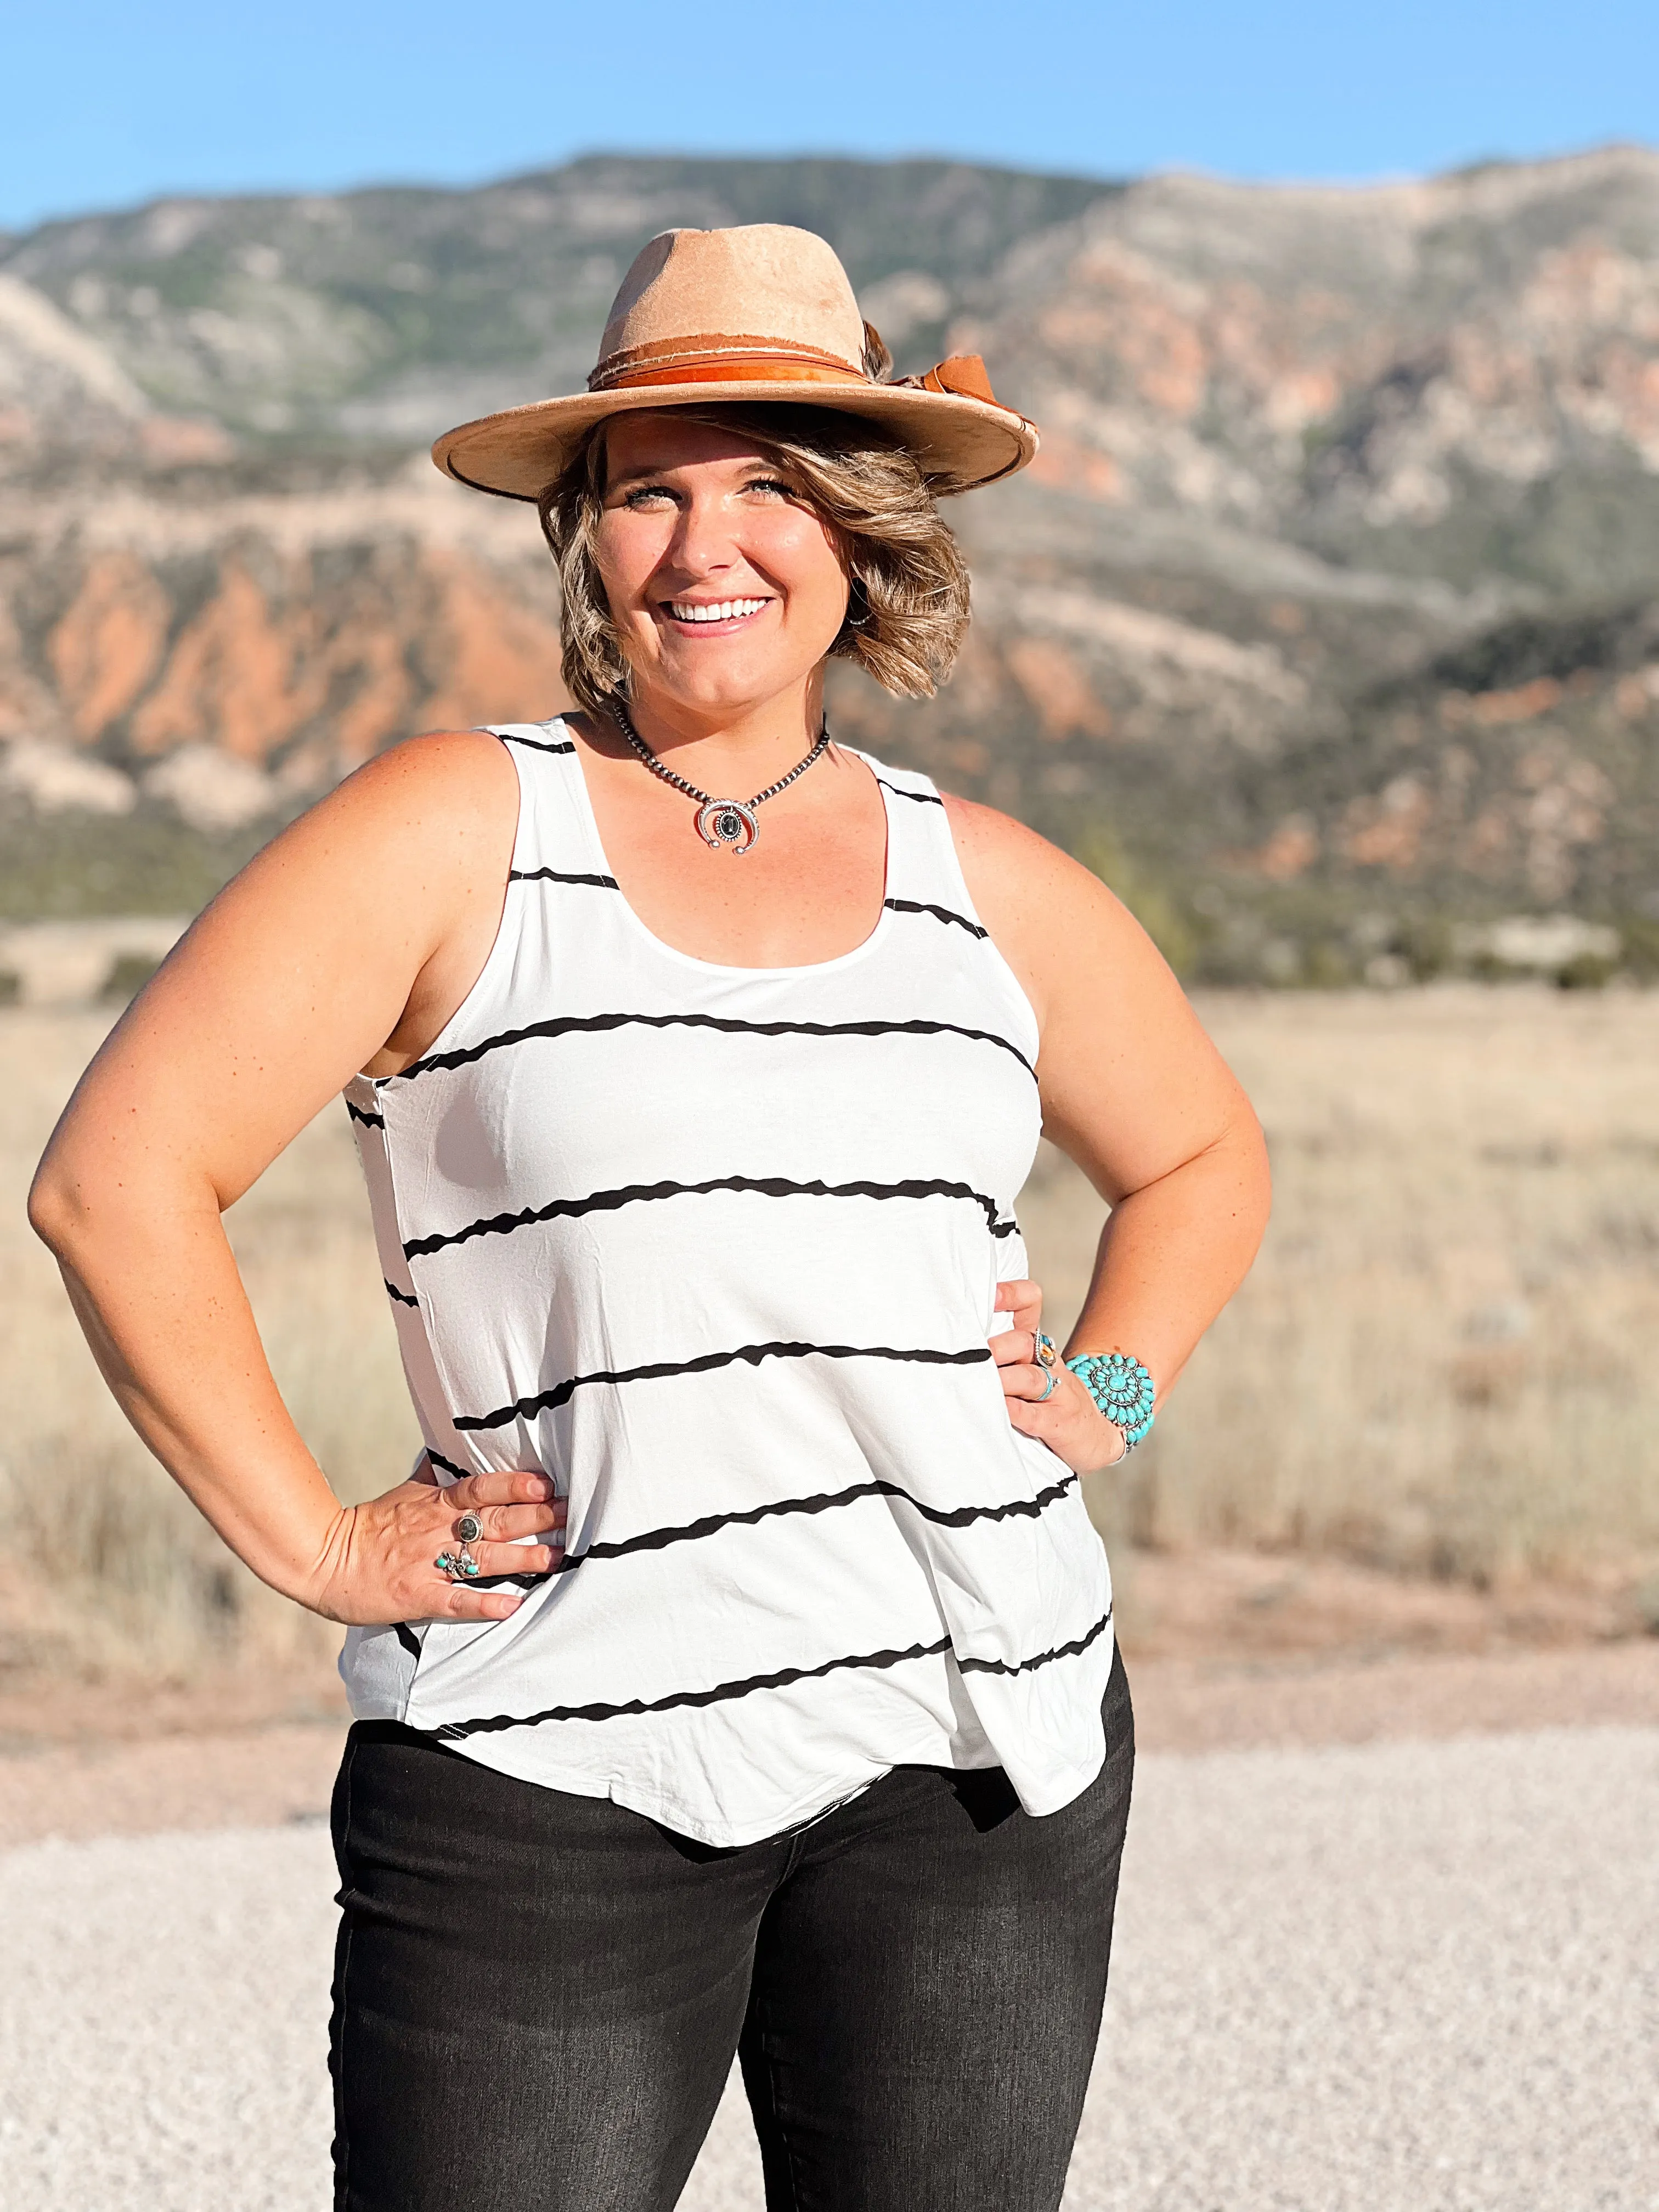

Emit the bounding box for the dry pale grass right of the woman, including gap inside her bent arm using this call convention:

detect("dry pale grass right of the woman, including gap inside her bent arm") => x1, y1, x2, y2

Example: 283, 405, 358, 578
1026, 984, 1659, 1599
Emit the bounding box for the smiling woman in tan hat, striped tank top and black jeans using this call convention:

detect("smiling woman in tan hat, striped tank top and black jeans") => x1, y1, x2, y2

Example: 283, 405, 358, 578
33, 225, 1267, 2212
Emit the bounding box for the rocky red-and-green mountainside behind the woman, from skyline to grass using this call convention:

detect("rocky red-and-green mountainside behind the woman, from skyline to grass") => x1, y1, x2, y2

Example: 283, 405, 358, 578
0, 148, 1659, 982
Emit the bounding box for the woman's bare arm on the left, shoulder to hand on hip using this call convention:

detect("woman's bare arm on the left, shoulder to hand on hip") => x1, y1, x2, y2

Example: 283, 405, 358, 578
29, 732, 562, 1621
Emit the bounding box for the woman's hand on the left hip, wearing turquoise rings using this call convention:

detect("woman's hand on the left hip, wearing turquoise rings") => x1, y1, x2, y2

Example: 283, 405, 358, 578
305, 1460, 566, 1628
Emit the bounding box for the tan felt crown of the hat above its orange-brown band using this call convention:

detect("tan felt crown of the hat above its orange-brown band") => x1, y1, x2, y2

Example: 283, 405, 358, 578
593, 223, 865, 378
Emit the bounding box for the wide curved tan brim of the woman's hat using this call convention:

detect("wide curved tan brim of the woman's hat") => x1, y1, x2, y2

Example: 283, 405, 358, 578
431, 378, 1037, 500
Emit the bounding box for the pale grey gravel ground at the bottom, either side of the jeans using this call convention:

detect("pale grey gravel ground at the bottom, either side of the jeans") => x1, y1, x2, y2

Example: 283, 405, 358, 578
0, 1728, 1659, 2212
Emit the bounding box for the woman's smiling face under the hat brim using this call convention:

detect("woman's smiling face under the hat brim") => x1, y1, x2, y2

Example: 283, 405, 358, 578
595, 409, 847, 719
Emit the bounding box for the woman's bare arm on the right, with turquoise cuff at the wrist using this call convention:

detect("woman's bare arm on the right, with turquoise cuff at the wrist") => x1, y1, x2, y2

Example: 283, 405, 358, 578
947, 799, 1269, 1466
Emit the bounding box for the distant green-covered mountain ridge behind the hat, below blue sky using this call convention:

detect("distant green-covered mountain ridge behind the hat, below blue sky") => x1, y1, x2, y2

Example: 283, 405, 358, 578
0, 157, 1108, 452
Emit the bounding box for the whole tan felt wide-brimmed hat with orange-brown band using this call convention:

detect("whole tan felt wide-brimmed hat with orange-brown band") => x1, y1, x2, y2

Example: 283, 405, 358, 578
431, 223, 1037, 500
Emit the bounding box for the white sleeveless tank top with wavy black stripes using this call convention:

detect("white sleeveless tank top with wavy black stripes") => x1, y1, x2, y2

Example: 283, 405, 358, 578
341, 721, 1113, 1845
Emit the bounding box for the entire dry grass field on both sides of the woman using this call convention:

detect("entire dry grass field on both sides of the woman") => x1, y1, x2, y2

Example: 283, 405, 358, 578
0, 986, 1659, 1688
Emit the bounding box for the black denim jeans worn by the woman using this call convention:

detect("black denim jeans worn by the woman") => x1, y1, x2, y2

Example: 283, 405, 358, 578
332, 1659, 1135, 2212
